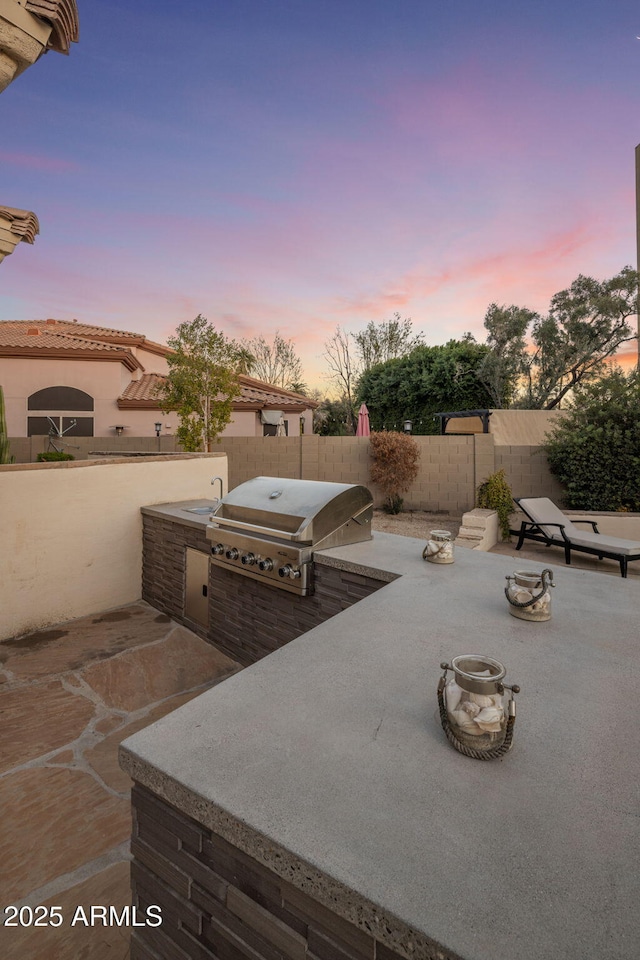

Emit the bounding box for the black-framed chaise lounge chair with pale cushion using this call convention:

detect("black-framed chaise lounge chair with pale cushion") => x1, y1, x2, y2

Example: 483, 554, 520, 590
514, 497, 640, 577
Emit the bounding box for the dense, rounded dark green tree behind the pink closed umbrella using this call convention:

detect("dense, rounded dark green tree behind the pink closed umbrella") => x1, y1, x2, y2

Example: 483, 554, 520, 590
358, 338, 492, 434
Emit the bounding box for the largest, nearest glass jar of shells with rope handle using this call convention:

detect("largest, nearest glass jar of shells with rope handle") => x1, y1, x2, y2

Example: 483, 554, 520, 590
438, 654, 520, 760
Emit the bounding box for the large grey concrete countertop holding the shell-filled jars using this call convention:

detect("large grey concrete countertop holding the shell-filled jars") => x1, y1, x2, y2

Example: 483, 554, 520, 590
122, 534, 640, 960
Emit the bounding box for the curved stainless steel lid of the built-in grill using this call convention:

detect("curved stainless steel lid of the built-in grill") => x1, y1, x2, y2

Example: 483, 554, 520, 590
211, 477, 373, 544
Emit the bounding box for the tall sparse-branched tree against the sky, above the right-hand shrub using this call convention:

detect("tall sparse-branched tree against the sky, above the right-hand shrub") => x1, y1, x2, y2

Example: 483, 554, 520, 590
478, 267, 638, 410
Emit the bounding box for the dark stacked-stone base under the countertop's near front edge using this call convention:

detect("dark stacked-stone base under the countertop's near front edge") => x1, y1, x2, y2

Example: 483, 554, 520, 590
131, 784, 457, 960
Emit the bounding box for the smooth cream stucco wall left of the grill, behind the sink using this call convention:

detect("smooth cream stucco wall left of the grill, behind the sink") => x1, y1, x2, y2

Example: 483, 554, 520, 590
0, 453, 228, 640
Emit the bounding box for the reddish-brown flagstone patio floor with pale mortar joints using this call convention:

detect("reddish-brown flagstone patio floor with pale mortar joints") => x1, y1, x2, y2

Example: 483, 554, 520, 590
0, 601, 240, 960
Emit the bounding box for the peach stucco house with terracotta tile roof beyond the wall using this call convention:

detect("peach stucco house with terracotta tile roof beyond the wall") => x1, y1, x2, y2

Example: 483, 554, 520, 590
0, 319, 317, 437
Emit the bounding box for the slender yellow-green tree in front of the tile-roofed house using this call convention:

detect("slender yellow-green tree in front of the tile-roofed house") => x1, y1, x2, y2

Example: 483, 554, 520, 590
160, 314, 240, 452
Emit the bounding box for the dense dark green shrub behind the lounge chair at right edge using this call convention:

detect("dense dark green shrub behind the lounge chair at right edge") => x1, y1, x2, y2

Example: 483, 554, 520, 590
545, 368, 640, 512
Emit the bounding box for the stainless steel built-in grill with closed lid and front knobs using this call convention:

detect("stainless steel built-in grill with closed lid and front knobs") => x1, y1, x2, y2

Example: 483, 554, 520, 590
207, 477, 373, 596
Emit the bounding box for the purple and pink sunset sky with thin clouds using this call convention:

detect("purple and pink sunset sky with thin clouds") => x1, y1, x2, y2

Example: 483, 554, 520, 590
0, 0, 640, 386
